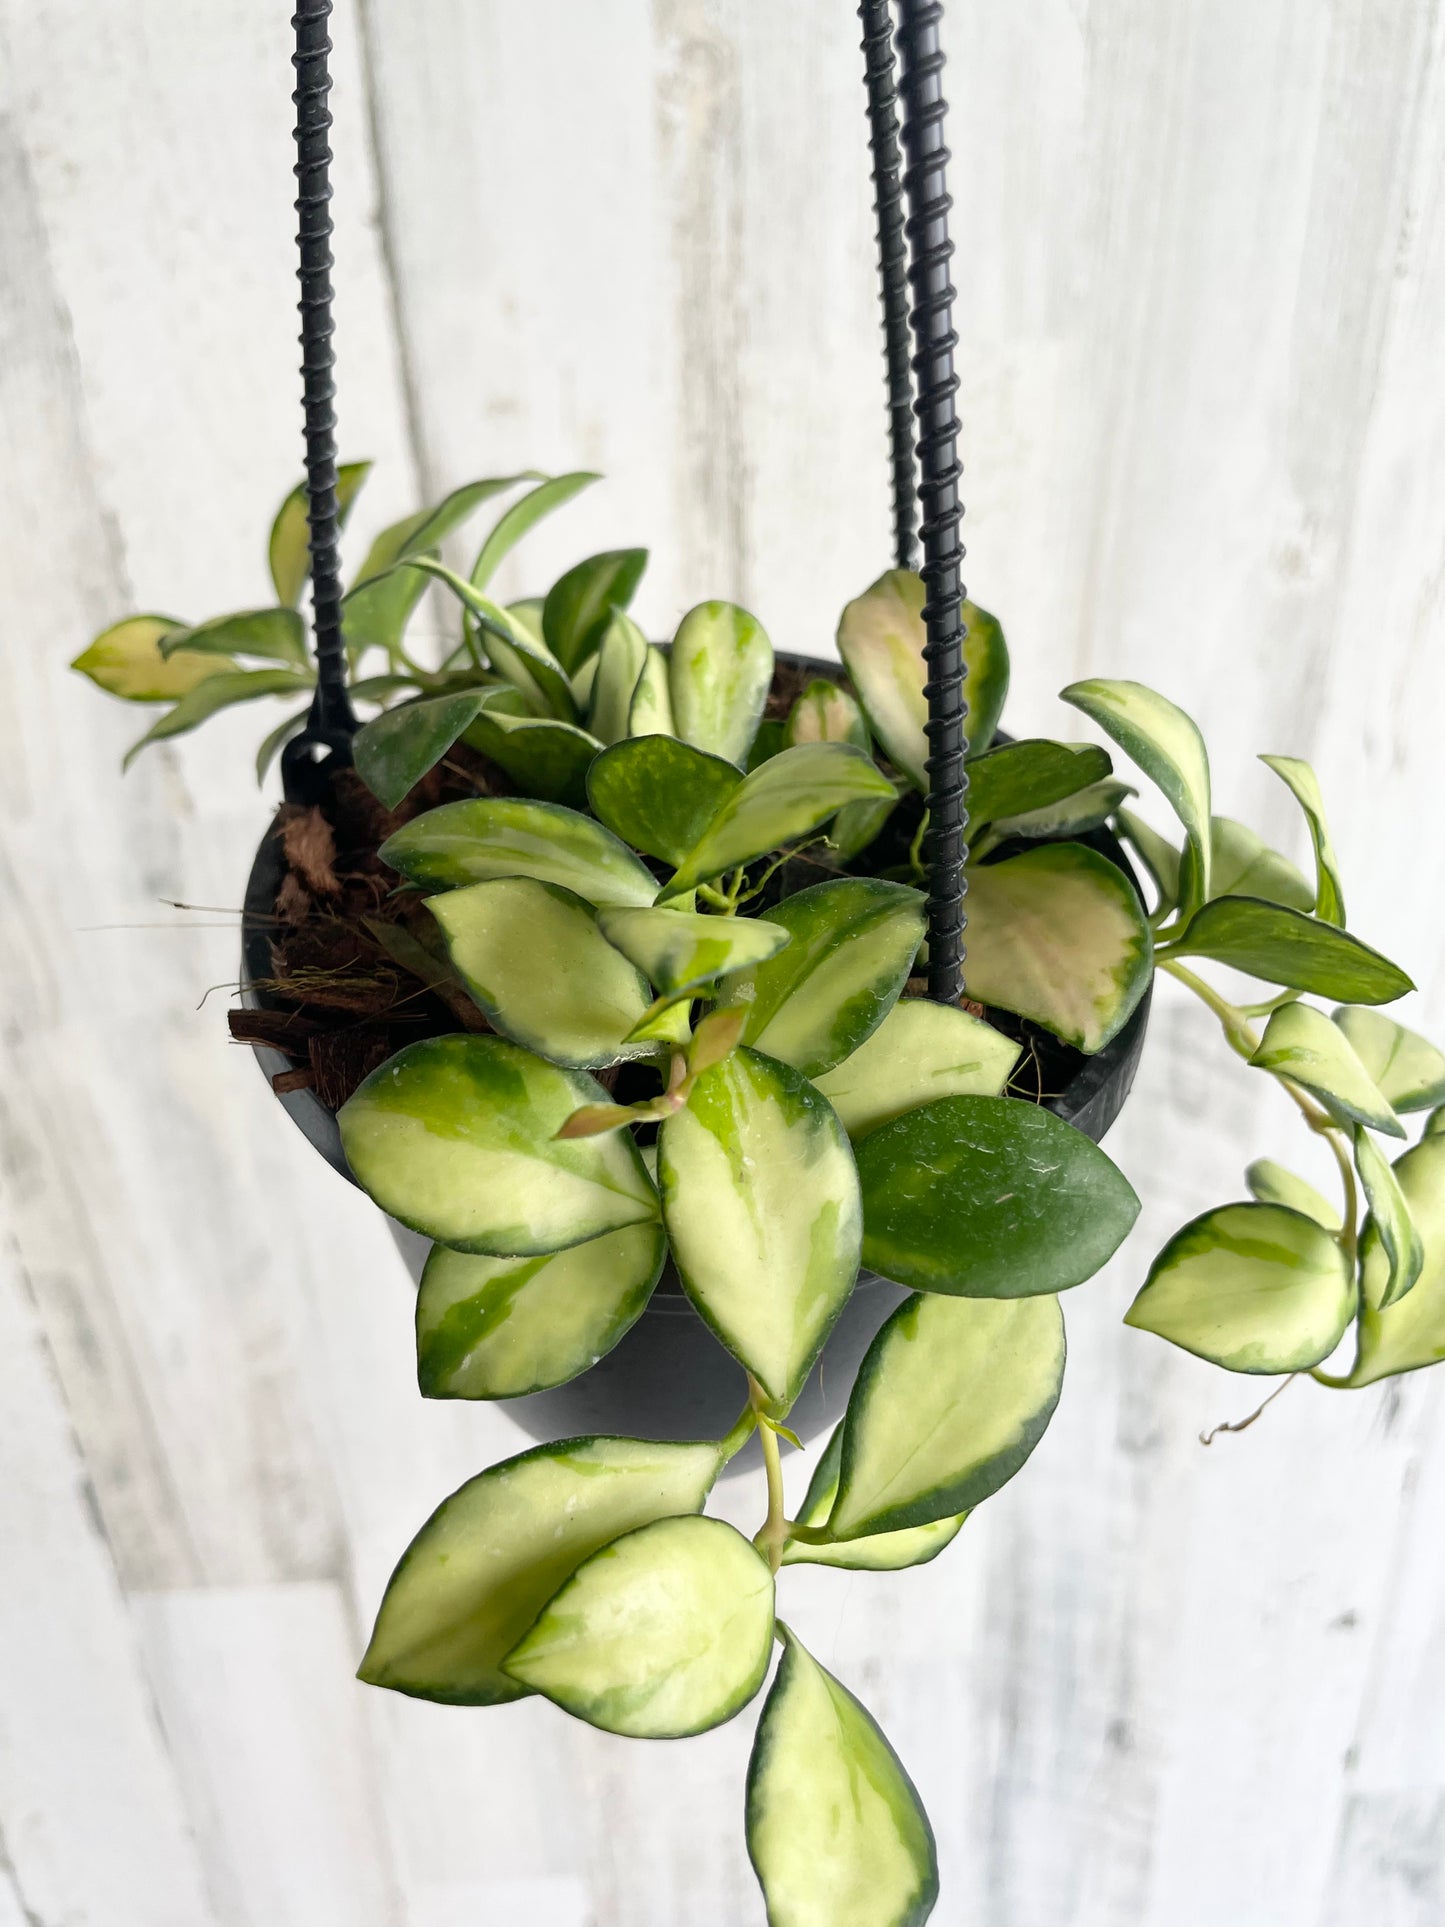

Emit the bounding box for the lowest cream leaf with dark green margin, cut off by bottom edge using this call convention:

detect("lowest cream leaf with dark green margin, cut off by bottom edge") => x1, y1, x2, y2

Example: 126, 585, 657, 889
748, 1626, 938, 1927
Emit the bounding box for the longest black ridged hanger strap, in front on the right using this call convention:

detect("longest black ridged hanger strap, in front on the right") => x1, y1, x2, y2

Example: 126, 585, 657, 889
898, 0, 969, 1004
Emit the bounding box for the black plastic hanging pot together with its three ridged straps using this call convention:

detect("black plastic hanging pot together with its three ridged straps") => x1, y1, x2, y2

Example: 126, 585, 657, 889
243, 0, 1148, 1463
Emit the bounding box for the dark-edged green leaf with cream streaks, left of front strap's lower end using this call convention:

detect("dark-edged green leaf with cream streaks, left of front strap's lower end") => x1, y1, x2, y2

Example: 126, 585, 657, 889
723, 882, 923, 1077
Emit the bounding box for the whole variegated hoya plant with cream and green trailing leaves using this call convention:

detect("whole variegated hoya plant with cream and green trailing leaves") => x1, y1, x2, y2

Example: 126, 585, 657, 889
77, 464, 1445, 1927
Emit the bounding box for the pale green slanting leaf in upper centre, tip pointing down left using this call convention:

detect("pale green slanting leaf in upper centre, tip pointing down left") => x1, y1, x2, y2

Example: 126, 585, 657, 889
663, 742, 898, 898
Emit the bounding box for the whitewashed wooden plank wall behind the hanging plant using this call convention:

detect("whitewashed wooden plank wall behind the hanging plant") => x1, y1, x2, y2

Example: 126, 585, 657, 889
0, 0, 1445, 1927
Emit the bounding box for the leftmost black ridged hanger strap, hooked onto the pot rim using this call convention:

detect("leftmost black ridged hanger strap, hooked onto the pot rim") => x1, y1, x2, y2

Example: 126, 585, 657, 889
281, 0, 356, 796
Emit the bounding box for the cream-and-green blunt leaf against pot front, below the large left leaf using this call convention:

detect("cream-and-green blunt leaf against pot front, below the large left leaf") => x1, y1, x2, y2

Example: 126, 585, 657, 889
416, 1224, 667, 1399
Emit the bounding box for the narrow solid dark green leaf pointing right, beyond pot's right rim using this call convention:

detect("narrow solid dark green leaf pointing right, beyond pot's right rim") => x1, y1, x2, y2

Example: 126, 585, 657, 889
1166, 896, 1414, 1004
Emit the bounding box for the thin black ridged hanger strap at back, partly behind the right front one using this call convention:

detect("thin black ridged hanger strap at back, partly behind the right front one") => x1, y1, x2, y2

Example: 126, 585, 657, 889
857, 0, 917, 568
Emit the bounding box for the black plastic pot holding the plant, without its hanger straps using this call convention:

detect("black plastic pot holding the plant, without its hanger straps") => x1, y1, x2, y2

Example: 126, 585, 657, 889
241, 657, 1152, 1465
